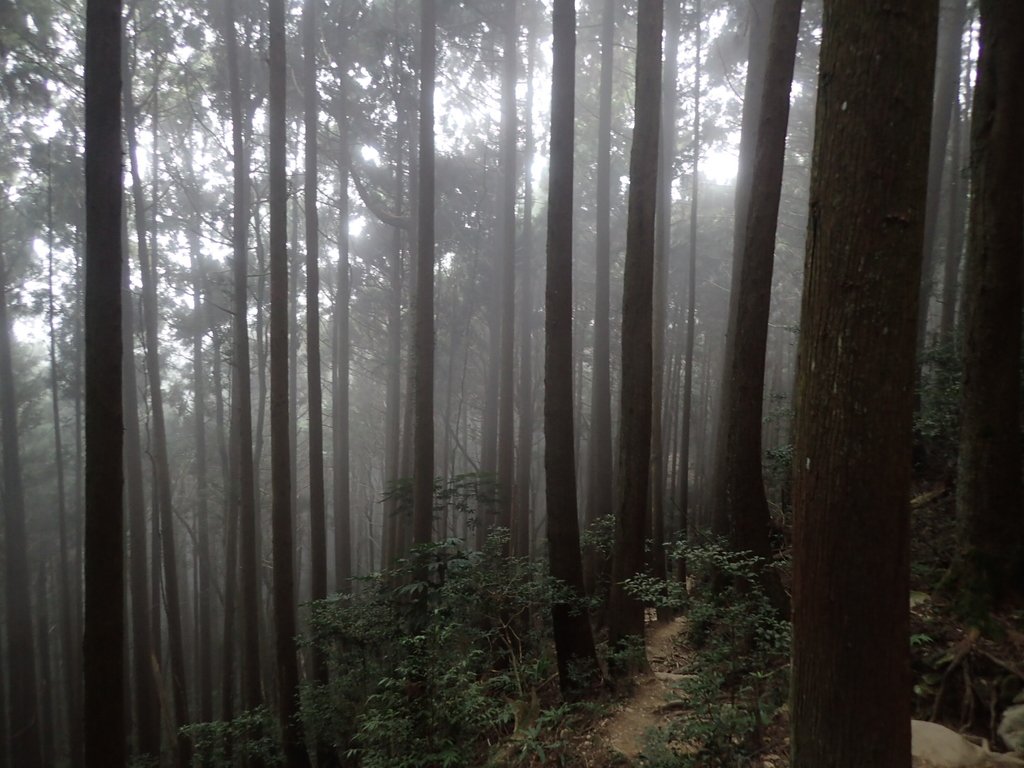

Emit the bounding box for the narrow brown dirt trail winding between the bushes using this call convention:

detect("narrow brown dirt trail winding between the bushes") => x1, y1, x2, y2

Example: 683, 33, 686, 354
594, 617, 687, 765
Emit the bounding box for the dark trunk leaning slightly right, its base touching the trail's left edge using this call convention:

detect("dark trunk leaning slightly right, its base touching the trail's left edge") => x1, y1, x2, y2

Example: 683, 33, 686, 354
608, 0, 663, 674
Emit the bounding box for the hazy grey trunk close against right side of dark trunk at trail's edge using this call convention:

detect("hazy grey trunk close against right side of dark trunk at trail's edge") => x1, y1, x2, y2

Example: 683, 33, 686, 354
649, 0, 681, 602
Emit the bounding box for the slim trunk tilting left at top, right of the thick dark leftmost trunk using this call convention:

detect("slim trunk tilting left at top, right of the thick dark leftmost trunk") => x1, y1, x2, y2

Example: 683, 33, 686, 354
124, 39, 190, 766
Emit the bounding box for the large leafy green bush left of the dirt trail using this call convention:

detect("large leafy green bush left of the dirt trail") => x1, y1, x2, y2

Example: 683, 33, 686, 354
303, 531, 577, 768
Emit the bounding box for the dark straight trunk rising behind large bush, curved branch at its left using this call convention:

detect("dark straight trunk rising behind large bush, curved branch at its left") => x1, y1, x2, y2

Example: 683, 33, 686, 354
413, 0, 437, 557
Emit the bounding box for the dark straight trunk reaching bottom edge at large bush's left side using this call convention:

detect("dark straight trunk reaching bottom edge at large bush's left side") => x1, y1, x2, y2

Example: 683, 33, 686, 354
268, 0, 309, 768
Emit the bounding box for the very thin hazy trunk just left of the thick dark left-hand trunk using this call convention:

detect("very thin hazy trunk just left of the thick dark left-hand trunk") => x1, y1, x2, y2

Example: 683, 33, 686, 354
46, 144, 86, 767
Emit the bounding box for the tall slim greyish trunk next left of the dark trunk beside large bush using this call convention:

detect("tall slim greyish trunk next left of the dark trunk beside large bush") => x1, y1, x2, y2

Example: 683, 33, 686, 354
223, 0, 263, 710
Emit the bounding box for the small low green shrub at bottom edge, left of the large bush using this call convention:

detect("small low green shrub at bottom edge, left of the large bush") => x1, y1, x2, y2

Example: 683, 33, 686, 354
181, 707, 284, 768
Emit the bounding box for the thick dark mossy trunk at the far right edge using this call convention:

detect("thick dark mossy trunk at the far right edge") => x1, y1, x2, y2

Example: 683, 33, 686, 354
952, 0, 1024, 622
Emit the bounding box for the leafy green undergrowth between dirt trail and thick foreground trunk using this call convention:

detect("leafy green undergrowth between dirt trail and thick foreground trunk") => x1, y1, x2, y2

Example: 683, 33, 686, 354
642, 542, 790, 768
